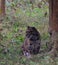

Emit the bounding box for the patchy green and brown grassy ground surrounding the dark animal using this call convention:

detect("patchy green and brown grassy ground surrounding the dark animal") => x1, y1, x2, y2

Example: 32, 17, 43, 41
0, 0, 58, 65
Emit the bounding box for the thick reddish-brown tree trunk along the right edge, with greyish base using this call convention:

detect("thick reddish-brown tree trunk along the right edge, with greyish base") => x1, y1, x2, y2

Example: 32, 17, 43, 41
49, 0, 58, 55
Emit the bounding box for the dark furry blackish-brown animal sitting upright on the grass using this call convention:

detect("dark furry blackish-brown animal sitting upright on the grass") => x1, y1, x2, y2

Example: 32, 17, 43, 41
22, 26, 41, 54
